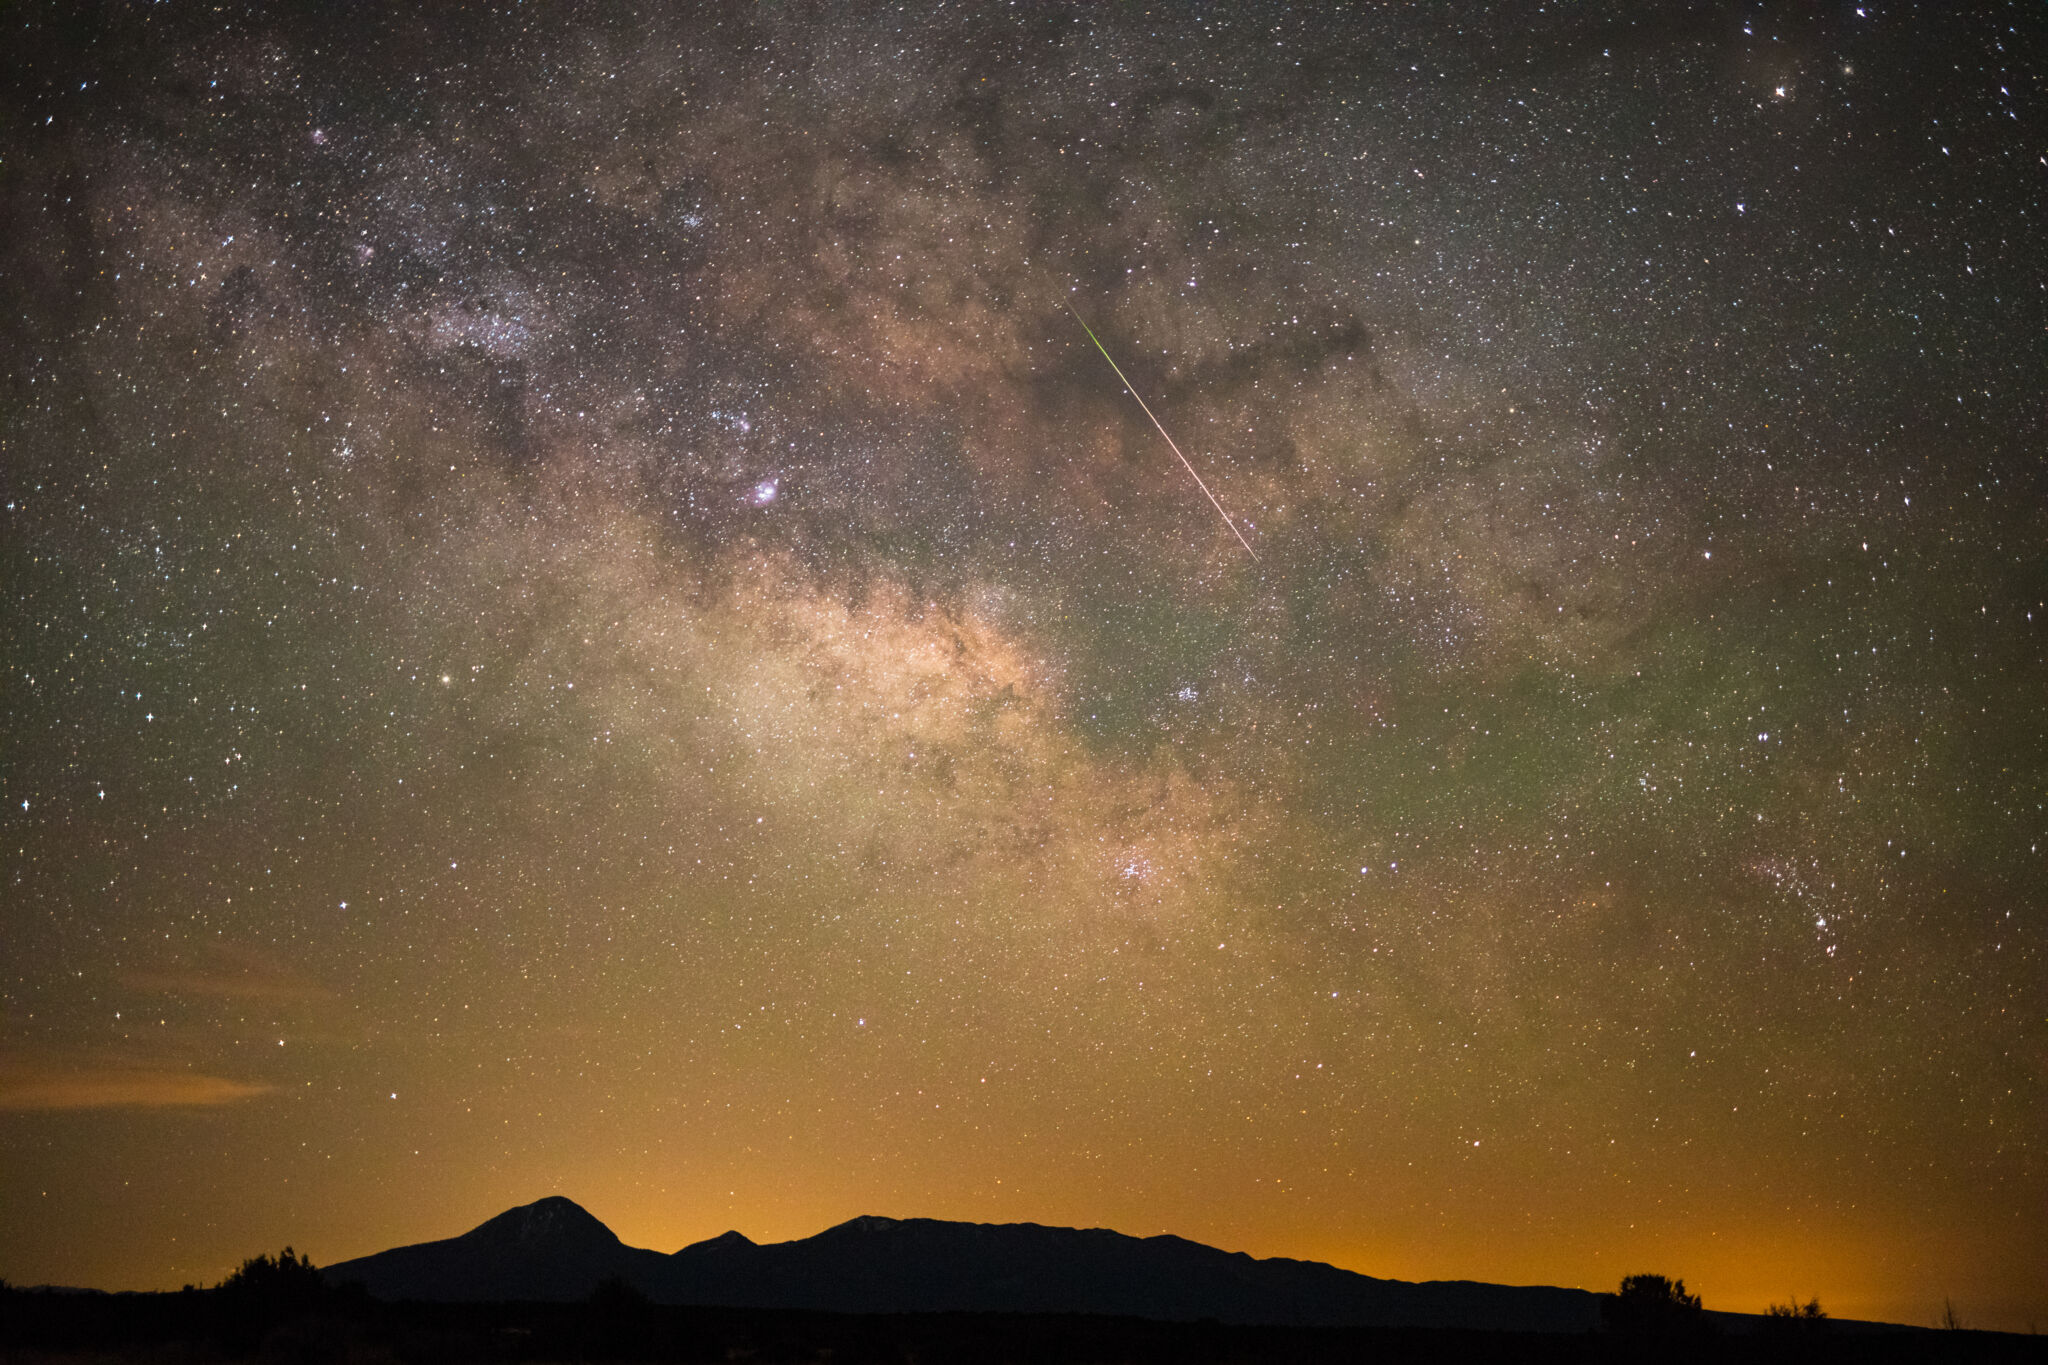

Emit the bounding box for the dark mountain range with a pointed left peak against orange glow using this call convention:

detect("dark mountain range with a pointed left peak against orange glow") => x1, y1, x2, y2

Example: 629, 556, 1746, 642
322, 1197, 1599, 1332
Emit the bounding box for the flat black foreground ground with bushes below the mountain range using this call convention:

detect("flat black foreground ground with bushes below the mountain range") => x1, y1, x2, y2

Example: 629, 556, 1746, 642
0, 1287, 2048, 1365
